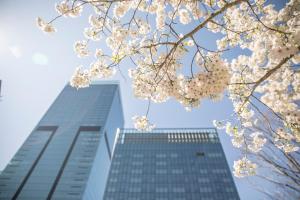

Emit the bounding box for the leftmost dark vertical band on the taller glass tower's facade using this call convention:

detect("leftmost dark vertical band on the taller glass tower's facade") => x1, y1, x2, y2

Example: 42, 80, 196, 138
12, 126, 57, 200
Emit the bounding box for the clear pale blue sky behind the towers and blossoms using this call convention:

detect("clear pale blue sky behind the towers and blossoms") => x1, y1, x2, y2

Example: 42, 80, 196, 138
0, 0, 284, 200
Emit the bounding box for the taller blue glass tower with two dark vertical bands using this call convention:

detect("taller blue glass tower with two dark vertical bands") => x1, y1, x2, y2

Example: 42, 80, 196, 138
0, 83, 124, 200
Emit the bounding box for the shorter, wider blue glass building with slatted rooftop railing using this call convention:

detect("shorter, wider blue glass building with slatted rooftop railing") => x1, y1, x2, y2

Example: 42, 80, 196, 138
104, 128, 239, 200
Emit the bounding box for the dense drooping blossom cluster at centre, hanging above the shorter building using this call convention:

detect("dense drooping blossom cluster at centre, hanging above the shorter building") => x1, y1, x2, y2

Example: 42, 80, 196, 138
130, 51, 229, 111
